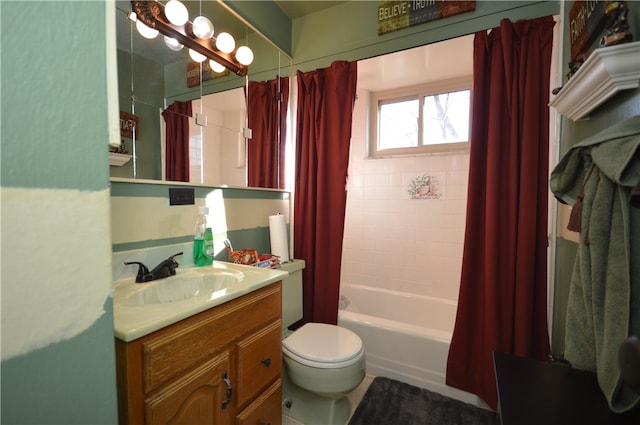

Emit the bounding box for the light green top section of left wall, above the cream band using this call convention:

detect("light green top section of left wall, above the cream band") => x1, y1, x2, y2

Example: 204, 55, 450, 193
1, 1, 109, 190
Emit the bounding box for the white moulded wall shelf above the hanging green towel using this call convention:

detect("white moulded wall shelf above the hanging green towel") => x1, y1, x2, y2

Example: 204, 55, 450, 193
549, 41, 640, 121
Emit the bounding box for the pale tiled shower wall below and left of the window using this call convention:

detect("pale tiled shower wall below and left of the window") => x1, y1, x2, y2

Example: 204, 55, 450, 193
341, 92, 469, 302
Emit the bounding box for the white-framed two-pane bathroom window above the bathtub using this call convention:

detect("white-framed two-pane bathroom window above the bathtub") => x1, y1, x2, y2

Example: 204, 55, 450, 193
369, 78, 471, 157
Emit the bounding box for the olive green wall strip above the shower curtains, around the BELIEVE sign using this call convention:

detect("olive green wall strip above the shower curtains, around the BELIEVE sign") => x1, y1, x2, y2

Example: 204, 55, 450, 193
292, 0, 559, 71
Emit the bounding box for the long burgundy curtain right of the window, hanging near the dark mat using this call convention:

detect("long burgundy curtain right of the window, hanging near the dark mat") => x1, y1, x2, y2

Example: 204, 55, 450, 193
446, 17, 554, 409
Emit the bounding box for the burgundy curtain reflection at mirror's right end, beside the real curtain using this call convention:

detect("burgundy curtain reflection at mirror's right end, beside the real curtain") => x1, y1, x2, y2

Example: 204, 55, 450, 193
245, 77, 289, 189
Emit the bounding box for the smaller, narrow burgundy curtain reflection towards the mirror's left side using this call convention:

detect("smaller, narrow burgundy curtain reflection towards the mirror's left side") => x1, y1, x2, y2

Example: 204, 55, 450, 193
162, 100, 191, 182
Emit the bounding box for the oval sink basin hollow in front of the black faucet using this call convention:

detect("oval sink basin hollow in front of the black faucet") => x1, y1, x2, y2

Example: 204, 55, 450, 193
125, 269, 244, 306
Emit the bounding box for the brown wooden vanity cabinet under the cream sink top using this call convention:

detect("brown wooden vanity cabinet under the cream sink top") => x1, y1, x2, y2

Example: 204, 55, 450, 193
116, 282, 282, 425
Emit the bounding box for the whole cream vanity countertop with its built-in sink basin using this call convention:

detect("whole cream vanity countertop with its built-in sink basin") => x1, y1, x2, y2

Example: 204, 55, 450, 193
113, 261, 289, 342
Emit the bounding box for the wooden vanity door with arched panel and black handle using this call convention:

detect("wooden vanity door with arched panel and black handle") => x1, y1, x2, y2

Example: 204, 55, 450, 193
144, 352, 233, 425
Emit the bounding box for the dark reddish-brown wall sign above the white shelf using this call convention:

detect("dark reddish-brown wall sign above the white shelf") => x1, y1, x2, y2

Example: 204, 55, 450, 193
569, 0, 607, 61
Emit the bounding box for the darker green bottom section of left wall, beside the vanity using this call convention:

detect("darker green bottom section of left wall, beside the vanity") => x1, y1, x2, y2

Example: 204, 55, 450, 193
0, 299, 118, 425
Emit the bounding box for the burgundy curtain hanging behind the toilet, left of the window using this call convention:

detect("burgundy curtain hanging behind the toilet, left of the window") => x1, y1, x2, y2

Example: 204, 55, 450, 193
294, 61, 357, 324
